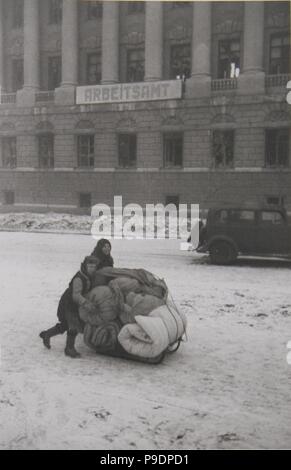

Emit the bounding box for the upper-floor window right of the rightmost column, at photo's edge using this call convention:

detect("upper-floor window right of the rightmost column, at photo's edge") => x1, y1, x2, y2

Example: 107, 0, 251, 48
269, 33, 290, 75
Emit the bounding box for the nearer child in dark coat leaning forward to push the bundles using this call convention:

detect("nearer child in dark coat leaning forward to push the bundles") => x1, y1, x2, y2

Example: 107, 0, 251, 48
39, 256, 99, 358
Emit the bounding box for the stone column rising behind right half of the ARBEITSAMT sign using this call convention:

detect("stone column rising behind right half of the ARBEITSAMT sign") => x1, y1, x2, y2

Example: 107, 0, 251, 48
145, 1, 163, 81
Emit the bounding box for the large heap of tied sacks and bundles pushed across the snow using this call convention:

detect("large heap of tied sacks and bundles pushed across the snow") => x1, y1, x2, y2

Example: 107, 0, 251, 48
79, 268, 186, 363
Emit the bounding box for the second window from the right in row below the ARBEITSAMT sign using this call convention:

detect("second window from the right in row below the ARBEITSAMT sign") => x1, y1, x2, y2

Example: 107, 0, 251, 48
212, 131, 234, 168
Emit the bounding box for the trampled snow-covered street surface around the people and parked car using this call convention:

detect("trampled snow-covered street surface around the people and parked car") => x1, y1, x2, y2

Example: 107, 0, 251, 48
0, 232, 291, 450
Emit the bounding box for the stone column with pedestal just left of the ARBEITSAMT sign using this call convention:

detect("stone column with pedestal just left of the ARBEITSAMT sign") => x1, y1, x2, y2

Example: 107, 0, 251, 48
55, 0, 79, 105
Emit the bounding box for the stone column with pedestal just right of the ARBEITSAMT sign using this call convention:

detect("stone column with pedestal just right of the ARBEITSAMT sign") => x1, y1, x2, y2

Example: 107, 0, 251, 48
186, 2, 211, 98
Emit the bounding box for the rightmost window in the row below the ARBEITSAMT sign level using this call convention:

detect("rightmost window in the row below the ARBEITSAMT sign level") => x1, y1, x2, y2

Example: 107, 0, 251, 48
265, 129, 290, 167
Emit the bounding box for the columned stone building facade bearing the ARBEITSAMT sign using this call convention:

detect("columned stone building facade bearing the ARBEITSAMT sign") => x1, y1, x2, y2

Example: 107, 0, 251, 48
0, 0, 291, 212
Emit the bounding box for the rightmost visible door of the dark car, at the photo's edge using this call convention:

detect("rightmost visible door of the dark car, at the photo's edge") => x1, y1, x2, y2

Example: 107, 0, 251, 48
257, 210, 290, 254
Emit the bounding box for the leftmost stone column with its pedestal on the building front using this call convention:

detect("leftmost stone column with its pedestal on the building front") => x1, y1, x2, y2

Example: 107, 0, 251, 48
17, 0, 40, 106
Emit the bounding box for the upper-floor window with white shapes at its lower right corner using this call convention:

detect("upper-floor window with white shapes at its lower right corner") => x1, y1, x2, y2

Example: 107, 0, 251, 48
218, 39, 241, 78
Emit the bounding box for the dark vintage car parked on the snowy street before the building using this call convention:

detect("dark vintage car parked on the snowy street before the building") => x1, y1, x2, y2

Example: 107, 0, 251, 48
197, 206, 291, 264
